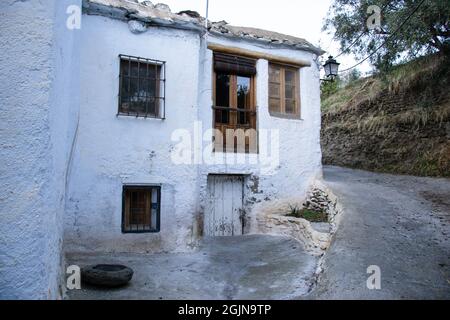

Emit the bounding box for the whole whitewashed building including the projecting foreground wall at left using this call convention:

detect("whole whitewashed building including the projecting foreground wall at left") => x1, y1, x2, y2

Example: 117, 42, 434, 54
0, 0, 322, 299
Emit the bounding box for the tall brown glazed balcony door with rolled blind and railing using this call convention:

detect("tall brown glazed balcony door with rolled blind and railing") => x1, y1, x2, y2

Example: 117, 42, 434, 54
213, 53, 257, 153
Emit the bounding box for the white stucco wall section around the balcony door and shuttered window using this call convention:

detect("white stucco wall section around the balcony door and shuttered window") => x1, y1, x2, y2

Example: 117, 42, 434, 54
198, 37, 322, 233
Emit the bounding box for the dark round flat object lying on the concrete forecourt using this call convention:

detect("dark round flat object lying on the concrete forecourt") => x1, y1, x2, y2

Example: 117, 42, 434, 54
81, 264, 133, 288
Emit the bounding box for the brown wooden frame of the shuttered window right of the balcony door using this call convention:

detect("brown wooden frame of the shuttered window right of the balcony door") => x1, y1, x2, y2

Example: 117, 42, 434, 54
268, 62, 301, 120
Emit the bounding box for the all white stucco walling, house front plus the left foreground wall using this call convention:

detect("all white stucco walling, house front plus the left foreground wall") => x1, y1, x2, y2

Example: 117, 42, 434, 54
0, 0, 321, 299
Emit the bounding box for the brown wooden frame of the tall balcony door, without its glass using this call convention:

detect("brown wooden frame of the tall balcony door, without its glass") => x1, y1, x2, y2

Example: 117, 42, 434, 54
212, 70, 259, 153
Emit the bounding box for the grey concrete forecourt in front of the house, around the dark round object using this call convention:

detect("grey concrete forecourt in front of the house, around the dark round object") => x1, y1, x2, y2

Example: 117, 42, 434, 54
67, 235, 317, 300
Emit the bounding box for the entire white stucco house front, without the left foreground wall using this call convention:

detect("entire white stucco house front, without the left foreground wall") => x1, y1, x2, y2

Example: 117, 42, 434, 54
65, 16, 321, 252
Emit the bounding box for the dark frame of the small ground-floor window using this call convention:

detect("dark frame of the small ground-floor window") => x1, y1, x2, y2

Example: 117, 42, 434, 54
122, 185, 161, 233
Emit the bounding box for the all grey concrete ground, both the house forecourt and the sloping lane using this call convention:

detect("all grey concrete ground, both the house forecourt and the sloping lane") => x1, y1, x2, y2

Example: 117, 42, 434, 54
67, 167, 450, 299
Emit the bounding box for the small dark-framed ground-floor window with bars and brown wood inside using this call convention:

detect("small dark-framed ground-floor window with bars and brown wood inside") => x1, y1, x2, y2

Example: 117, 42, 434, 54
122, 186, 161, 233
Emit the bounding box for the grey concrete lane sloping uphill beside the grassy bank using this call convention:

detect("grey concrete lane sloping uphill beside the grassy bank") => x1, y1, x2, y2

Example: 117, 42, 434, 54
308, 167, 450, 299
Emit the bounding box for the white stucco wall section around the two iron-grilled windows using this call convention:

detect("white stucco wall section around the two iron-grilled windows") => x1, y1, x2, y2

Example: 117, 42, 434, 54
65, 15, 200, 252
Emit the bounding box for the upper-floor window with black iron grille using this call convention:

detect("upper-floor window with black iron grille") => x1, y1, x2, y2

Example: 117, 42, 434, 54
118, 55, 166, 119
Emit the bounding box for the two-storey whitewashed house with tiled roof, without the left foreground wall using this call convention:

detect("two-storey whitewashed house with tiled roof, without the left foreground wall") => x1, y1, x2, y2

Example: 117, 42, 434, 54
64, 0, 322, 252
